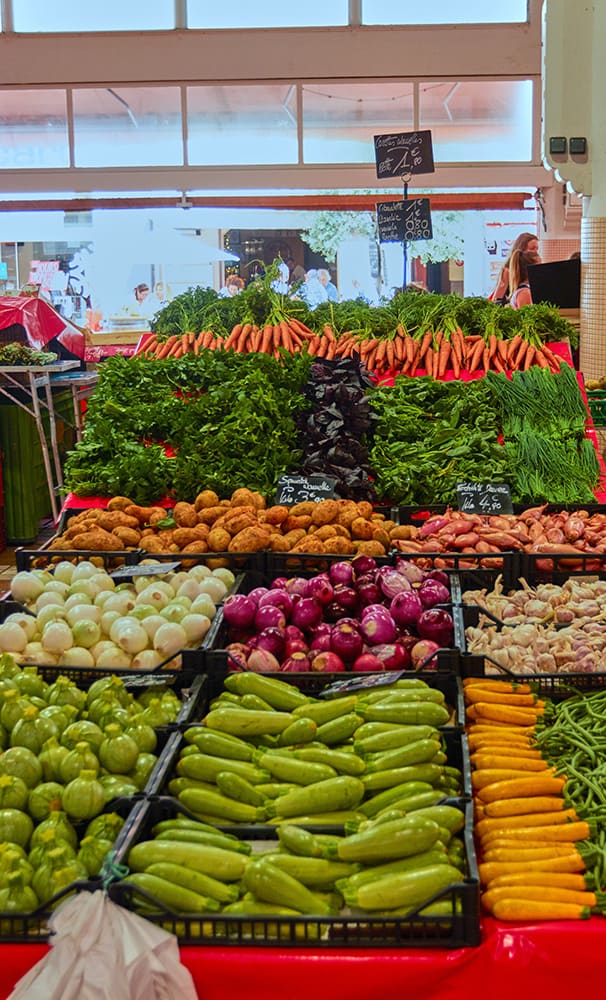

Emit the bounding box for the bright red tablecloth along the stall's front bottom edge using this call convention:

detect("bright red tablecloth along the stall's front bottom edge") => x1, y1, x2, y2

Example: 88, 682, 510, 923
0, 917, 606, 1000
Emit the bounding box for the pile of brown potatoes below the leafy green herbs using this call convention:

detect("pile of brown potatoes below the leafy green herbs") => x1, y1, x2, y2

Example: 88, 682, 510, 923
49, 489, 408, 556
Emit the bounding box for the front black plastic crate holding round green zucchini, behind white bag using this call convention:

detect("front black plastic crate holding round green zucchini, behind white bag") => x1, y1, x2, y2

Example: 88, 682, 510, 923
0, 795, 145, 944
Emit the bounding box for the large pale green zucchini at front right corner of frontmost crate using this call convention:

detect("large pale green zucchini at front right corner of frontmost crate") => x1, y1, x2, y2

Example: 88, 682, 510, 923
343, 864, 461, 910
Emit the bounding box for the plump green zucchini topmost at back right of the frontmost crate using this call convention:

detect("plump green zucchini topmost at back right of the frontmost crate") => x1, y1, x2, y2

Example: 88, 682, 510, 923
337, 815, 440, 864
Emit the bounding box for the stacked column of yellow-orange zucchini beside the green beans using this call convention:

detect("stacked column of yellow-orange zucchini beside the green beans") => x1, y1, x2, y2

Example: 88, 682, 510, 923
463, 678, 604, 921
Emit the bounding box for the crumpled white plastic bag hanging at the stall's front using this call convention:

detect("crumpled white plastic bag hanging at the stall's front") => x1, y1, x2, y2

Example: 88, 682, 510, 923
9, 891, 198, 1000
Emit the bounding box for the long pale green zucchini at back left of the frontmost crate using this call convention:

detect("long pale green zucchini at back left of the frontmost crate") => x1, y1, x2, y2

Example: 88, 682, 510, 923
127, 840, 249, 882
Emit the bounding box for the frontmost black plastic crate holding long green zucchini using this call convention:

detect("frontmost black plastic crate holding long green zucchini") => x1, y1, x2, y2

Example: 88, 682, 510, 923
108, 798, 480, 949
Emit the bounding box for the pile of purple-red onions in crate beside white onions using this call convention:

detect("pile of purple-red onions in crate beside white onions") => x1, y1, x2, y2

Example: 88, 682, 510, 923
223, 556, 453, 673
